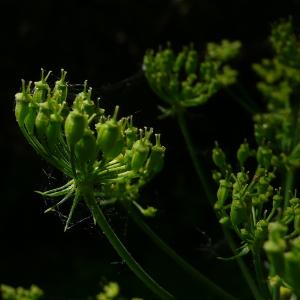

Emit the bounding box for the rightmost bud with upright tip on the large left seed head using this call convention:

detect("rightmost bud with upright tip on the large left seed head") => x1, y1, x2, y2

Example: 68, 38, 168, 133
146, 134, 166, 174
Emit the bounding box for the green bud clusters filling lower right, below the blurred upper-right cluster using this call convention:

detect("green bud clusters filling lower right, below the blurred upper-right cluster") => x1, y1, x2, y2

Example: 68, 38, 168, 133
212, 143, 300, 297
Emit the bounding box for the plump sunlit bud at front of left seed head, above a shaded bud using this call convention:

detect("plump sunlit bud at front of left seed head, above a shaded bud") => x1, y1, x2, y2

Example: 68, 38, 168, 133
65, 110, 87, 149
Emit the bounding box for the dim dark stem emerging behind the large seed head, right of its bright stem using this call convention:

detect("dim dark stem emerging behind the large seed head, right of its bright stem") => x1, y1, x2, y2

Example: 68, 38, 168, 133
125, 204, 236, 300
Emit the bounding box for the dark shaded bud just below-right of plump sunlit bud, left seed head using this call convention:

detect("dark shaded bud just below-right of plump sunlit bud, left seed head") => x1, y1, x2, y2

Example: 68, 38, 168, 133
75, 129, 96, 165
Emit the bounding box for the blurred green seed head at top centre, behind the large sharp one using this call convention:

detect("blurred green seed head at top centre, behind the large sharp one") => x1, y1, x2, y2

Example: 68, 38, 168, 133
143, 40, 241, 113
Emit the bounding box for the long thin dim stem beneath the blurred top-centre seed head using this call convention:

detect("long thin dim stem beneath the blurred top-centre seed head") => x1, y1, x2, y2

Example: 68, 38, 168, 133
176, 107, 263, 300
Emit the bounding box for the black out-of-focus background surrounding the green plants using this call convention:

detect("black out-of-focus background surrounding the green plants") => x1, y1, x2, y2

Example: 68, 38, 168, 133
0, 0, 300, 300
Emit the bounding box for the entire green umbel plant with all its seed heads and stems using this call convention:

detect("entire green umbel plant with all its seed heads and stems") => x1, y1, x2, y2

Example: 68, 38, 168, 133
15, 20, 300, 300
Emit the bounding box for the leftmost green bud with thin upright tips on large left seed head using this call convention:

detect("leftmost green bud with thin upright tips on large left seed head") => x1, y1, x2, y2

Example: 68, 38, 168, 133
15, 80, 32, 126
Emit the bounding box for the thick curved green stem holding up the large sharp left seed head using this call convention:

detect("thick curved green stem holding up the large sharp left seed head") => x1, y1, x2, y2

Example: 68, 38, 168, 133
80, 185, 175, 300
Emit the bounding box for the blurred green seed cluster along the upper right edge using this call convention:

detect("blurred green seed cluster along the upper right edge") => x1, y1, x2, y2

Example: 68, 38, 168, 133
253, 20, 300, 159
